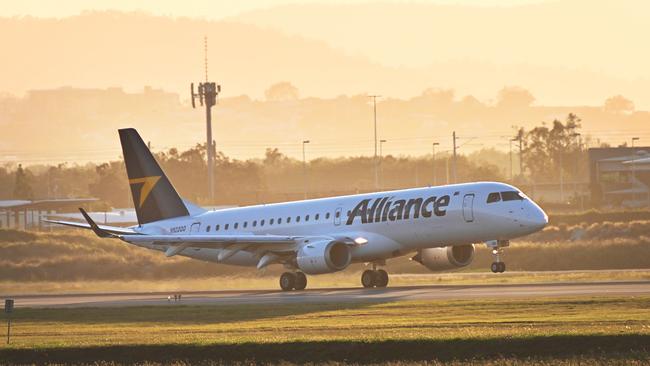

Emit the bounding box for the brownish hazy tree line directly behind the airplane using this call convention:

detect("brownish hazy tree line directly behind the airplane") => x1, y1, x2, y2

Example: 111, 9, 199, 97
0, 114, 589, 208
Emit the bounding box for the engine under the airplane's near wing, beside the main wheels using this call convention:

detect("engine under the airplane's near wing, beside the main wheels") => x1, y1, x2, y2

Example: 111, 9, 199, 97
296, 240, 352, 274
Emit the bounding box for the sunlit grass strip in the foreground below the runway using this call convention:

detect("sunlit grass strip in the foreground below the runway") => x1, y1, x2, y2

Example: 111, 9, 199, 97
0, 296, 650, 364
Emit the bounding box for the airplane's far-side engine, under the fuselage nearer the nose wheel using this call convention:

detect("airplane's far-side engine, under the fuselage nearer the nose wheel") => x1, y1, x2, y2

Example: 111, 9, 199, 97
411, 244, 474, 271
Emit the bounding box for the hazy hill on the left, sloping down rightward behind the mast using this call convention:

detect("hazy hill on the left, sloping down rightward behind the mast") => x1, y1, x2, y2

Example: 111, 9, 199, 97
0, 12, 400, 98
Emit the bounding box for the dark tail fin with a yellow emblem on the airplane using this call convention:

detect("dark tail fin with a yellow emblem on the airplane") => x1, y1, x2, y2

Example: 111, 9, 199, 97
119, 128, 189, 225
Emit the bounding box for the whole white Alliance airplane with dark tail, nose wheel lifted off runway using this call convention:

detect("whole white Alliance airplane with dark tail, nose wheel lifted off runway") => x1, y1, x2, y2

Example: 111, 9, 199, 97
50, 128, 548, 291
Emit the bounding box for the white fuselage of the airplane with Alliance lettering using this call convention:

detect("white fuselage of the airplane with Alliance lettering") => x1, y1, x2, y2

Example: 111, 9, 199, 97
136, 182, 548, 266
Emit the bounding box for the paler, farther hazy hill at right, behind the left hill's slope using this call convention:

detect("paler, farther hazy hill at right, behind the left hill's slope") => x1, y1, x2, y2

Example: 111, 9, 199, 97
231, 0, 650, 109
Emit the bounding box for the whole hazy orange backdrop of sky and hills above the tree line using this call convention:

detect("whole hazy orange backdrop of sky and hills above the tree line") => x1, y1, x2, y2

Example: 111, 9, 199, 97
0, 0, 650, 161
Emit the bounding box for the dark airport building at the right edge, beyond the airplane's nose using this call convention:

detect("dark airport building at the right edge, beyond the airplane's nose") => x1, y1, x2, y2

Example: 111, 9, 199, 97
589, 146, 650, 208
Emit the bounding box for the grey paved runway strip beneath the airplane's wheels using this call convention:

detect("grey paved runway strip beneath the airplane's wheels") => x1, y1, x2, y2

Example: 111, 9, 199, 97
13, 281, 650, 307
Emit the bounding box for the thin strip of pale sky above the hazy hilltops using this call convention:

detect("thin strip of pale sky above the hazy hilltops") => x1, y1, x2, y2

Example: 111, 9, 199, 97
0, 0, 548, 18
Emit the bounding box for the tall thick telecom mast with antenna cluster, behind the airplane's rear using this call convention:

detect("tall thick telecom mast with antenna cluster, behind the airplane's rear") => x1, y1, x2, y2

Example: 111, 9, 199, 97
190, 36, 221, 204
